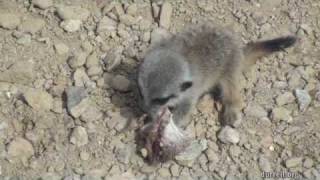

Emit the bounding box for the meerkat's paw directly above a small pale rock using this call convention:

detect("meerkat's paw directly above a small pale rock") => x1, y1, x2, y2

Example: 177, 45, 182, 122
221, 107, 242, 127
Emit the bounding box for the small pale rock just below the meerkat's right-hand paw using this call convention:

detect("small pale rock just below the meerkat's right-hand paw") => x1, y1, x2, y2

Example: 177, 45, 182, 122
218, 126, 240, 144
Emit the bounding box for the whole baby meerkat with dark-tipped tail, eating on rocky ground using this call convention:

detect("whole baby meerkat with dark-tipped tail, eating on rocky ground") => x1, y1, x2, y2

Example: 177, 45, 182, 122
138, 23, 296, 126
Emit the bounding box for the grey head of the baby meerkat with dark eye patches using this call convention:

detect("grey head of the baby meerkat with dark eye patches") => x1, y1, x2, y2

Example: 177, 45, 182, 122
138, 50, 193, 119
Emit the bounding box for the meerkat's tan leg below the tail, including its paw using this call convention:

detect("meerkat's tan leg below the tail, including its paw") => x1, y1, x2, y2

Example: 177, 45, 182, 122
219, 77, 242, 127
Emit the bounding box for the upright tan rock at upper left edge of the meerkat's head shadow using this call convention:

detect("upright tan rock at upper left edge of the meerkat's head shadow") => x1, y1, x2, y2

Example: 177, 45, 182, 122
103, 47, 123, 72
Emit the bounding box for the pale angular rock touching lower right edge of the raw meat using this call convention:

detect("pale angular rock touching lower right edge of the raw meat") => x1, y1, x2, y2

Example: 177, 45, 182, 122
175, 139, 208, 167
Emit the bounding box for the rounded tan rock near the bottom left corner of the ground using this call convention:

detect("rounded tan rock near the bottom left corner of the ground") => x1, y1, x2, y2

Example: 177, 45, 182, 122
7, 137, 34, 159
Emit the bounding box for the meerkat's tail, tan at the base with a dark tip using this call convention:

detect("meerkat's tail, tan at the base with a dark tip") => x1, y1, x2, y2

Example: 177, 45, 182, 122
244, 36, 297, 67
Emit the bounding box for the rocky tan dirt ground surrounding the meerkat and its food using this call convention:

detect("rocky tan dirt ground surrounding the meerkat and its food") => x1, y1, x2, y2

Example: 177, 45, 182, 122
0, 0, 320, 180
